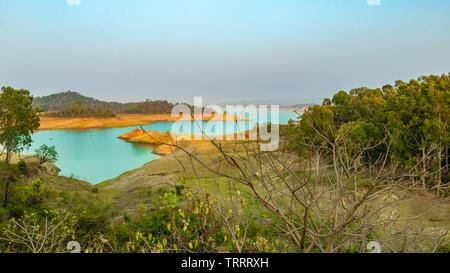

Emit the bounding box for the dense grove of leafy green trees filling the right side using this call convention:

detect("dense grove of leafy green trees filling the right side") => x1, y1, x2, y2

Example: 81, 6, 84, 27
287, 74, 450, 191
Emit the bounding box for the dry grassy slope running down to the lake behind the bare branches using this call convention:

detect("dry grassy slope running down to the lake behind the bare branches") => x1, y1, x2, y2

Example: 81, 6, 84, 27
7, 144, 450, 251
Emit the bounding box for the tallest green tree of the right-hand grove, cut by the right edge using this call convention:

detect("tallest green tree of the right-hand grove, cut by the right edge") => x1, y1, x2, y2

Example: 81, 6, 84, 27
387, 74, 450, 189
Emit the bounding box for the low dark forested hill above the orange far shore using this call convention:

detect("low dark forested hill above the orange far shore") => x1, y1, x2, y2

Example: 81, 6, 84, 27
33, 91, 179, 117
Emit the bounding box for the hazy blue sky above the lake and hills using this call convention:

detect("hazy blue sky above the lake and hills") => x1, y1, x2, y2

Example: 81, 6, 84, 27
0, 0, 450, 102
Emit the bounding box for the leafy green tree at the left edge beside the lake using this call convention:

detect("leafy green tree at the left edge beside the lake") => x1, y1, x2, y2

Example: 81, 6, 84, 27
0, 87, 39, 164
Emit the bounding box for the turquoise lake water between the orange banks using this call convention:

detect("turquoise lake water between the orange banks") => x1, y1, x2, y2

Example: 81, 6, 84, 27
24, 111, 297, 184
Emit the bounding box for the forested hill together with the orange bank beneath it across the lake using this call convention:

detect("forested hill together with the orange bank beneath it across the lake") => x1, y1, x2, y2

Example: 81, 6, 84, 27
33, 91, 247, 131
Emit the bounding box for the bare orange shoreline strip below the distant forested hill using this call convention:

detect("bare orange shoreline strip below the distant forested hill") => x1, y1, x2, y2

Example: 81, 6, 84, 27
39, 114, 248, 131
